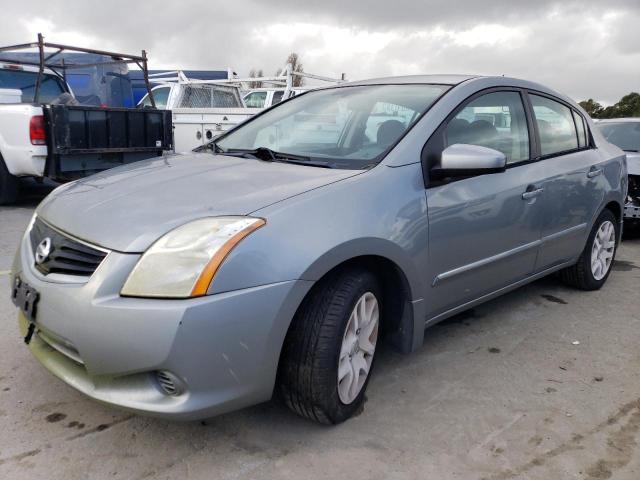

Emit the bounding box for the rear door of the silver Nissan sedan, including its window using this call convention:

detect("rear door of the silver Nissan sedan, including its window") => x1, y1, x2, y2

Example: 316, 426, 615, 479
528, 92, 606, 271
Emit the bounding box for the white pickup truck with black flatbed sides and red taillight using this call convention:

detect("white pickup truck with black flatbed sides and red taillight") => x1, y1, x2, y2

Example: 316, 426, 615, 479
0, 61, 172, 205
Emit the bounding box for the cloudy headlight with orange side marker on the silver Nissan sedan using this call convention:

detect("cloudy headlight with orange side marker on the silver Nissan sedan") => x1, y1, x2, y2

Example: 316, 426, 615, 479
120, 217, 266, 298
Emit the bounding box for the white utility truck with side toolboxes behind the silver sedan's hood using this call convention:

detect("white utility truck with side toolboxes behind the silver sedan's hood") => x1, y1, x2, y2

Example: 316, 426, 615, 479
138, 72, 258, 152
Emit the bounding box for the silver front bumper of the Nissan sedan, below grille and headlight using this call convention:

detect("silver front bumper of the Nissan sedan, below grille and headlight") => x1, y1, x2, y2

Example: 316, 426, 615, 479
12, 231, 311, 420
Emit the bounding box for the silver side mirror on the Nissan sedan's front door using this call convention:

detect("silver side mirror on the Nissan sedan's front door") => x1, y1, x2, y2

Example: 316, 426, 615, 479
431, 143, 507, 178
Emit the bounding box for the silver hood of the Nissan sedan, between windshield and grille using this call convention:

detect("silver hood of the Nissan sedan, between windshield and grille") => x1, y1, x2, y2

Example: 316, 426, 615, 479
37, 153, 362, 252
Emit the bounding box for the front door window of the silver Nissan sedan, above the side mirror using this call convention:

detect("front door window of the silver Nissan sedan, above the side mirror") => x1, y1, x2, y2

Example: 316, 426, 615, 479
445, 92, 529, 163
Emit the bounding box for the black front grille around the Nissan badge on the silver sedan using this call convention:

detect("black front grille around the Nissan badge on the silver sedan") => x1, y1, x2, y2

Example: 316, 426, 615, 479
30, 218, 107, 277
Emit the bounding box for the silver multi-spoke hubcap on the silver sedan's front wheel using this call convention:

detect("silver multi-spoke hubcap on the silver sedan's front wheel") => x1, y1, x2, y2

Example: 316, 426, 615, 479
338, 292, 380, 405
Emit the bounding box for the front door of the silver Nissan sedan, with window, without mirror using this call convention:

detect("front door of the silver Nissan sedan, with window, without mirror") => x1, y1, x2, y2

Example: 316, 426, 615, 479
425, 89, 545, 317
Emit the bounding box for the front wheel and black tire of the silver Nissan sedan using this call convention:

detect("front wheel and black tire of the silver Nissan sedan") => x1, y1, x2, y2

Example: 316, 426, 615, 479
278, 268, 382, 424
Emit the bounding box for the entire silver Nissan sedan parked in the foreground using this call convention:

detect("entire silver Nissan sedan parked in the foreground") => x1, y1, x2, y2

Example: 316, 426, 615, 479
11, 76, 627, 423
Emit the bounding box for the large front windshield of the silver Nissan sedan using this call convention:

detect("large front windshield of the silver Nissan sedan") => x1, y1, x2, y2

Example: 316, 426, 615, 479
216, 84, 450, 169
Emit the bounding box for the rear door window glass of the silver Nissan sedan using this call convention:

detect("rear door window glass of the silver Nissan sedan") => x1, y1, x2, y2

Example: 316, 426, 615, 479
529, 95, 584, 156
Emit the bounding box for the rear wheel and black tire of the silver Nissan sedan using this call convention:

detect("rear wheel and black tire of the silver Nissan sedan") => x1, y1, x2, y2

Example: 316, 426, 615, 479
560, 210, 620, 290
